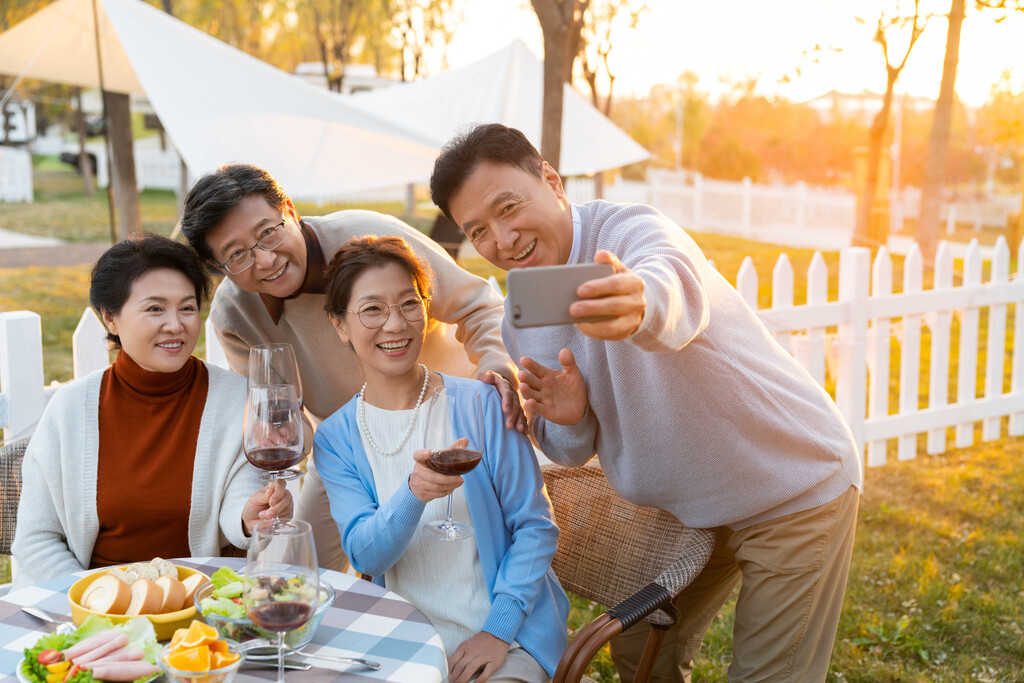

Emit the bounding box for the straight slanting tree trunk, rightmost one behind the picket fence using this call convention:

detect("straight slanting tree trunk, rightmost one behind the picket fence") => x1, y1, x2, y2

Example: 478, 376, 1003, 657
915, 0, 966, 263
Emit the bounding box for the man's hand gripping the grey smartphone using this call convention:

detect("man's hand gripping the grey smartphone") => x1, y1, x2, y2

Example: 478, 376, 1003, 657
569, 250, 646, 341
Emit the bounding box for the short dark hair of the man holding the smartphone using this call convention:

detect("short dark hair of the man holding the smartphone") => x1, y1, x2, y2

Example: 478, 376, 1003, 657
430, 123, 544, 222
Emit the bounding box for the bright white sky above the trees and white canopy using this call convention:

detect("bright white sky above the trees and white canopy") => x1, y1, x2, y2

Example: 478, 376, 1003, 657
436, 0, 1024, 106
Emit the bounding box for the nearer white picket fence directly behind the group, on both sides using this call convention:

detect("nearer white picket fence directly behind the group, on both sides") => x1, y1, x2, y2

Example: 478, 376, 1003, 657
0, 238, 1024, 466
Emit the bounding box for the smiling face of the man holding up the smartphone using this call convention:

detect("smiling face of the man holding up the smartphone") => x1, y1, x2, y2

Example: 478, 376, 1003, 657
449, 161, 572, 270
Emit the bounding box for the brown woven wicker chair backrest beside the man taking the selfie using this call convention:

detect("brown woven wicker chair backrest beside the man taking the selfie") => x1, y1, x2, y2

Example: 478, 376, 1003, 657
541, 465, 708, 606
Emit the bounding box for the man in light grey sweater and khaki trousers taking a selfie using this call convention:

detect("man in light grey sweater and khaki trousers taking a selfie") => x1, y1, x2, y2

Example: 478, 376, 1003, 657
430, 124, 862, 682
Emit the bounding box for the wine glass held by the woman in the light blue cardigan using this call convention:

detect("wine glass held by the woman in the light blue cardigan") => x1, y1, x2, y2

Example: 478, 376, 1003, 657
423, 386, 483, 541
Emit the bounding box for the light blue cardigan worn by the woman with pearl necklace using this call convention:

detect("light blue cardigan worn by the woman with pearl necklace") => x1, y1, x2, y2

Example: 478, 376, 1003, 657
313, 375, 568, 675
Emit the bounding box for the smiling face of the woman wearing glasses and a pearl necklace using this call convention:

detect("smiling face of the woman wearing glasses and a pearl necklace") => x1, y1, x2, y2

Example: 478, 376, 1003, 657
331, 263, 426, 384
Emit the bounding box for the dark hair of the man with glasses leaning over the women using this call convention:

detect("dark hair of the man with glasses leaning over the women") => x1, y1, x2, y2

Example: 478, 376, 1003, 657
181, 164, 291, 261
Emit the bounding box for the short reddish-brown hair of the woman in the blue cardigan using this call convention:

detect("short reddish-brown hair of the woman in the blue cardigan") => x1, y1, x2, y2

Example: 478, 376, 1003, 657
324, 234, 431, 317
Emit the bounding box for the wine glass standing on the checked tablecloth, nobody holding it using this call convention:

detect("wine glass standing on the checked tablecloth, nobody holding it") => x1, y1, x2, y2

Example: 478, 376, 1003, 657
242, 520, 319, 683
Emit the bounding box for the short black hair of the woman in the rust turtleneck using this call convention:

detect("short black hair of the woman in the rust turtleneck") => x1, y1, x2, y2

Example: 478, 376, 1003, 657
89, 233, 210, 348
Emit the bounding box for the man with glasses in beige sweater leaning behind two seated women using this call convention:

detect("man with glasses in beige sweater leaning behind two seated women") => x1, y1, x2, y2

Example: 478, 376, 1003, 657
181, 164, 525, 570
